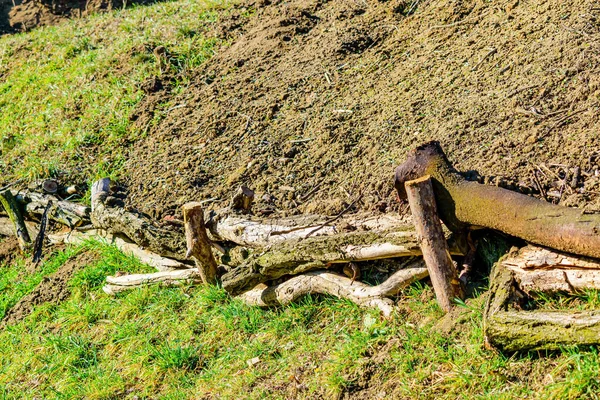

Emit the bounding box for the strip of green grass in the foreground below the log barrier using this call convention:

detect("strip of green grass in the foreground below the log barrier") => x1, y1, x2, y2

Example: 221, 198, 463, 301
0, 242, 600, 399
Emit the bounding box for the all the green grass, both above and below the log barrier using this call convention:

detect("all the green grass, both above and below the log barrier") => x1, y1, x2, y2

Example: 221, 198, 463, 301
0, 0, 599, 399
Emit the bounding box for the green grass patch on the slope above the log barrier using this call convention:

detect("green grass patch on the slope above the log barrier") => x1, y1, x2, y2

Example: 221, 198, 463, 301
0, 0, 231, 181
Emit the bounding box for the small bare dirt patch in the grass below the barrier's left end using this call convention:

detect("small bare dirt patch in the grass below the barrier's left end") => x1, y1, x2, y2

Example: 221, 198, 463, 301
2, 253, 98, 325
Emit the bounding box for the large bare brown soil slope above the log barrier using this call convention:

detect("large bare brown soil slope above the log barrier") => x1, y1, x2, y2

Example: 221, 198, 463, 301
125, 0, 600, 222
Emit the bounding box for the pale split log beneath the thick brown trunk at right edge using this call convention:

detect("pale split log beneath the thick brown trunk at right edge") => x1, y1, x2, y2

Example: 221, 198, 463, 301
502, 246, 600, 296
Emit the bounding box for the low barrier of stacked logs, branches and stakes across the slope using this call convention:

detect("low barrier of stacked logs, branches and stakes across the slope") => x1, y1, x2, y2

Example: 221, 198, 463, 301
0, 142, 600, 351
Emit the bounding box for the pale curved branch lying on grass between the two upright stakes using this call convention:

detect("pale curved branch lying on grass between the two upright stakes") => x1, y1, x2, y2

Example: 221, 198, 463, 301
238, 271, 394, 317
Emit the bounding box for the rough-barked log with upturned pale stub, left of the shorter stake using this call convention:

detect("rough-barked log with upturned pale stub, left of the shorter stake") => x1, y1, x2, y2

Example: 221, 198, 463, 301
90, 178, 185, 259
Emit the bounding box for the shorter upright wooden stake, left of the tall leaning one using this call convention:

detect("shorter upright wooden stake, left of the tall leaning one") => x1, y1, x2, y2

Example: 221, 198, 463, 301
183, 202, 218, 284
